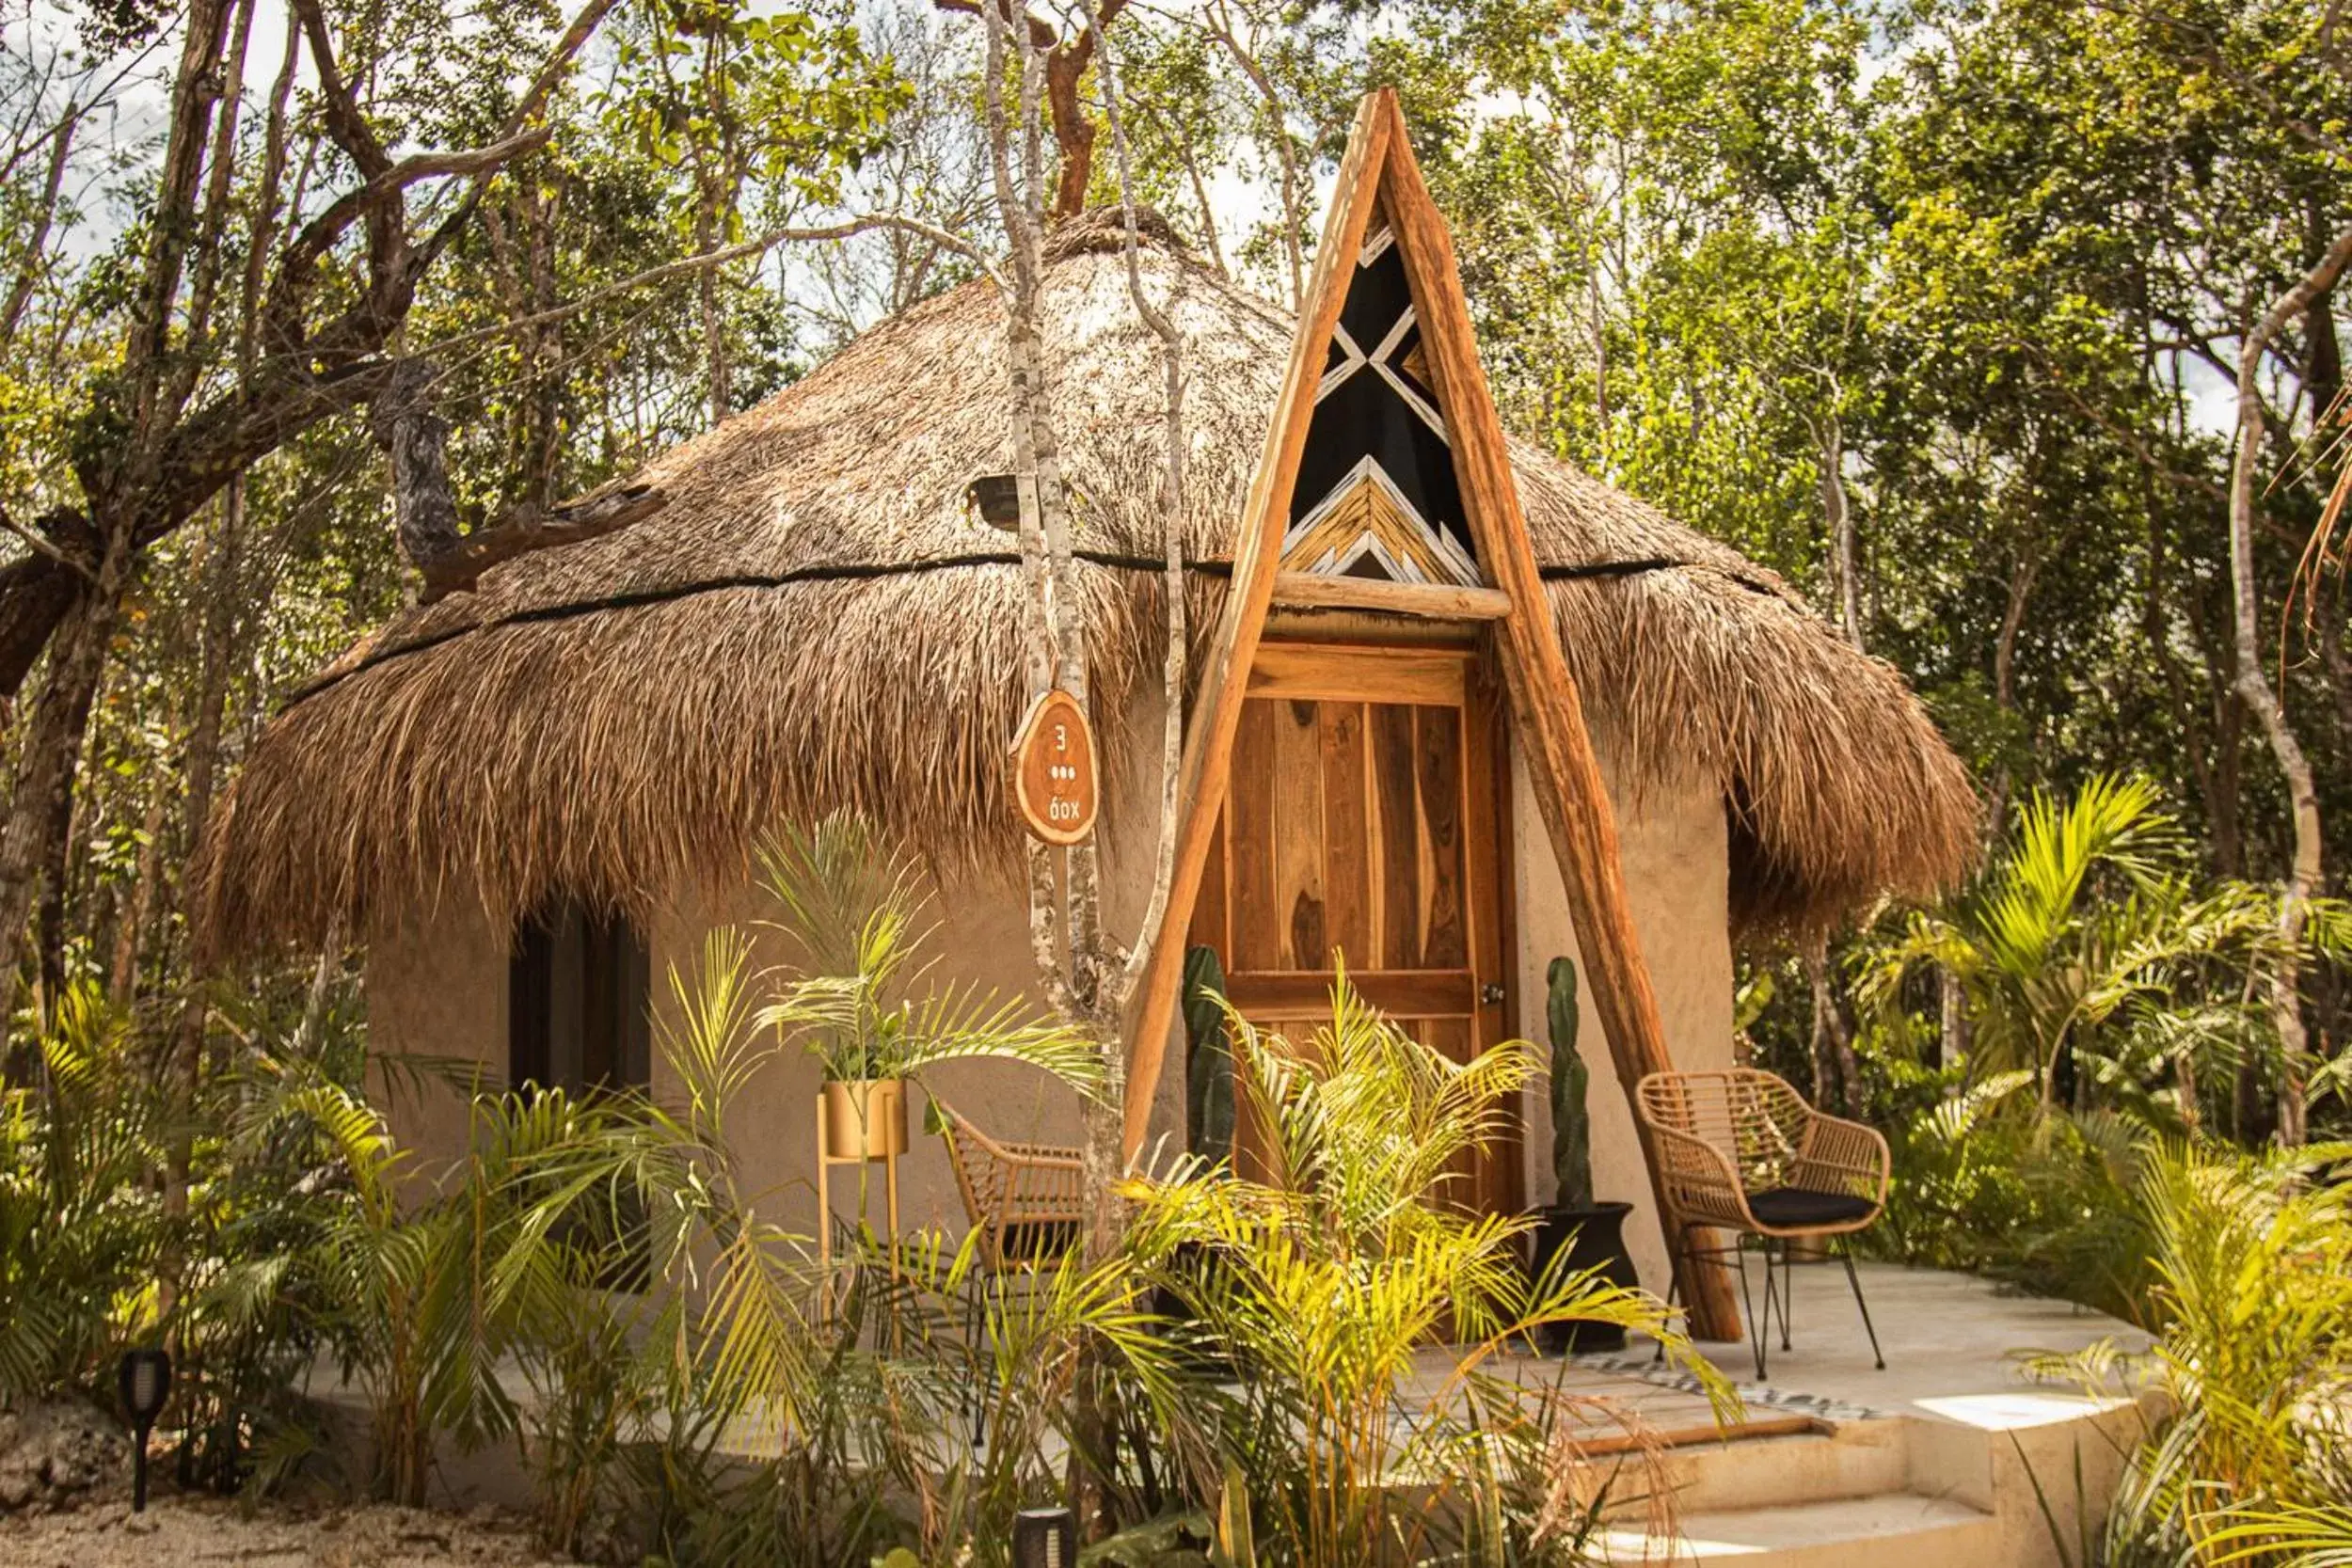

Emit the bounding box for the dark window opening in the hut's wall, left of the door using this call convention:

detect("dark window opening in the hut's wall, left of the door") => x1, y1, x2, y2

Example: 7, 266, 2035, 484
506, 900, 654, 1093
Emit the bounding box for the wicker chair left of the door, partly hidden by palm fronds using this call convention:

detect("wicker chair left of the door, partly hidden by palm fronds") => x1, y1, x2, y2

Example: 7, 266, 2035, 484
931, 1101, 1087, 1446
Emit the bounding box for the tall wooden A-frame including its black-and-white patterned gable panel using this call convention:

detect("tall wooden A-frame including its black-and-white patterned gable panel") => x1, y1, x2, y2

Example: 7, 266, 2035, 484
1127, 89, 1740, 1340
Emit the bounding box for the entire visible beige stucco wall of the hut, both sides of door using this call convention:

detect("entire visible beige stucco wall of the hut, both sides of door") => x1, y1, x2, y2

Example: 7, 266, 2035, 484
367, 686, 1731, 1291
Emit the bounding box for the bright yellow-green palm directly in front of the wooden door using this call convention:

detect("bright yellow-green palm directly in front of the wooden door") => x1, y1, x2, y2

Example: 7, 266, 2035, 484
1124, 978, 1731, 1566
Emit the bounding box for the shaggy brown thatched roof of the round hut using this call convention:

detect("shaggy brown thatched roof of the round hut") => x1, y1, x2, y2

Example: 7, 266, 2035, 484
202, 211, 1976, 955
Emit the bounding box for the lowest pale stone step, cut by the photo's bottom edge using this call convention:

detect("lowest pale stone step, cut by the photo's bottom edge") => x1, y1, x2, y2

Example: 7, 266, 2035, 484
1599, 1493, 2002, 1568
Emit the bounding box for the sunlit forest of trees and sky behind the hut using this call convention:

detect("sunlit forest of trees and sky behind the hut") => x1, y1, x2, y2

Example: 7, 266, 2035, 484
0, 0, 2352, 1143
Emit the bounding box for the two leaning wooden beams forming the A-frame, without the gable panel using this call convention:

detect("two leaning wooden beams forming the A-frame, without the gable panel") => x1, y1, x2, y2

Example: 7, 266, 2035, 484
1127, 89, 1740, 1340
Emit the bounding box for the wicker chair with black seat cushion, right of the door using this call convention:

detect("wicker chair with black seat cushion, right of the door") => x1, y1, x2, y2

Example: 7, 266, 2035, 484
1637, 1068, 1891, 1380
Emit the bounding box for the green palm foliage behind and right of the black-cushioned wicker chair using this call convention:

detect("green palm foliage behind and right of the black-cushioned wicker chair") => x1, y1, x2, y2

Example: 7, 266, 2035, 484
1856, 778, 2341, 1323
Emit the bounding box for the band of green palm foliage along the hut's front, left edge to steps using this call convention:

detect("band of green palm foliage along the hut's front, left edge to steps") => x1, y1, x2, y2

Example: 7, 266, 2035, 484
0, 911, 1729, 1568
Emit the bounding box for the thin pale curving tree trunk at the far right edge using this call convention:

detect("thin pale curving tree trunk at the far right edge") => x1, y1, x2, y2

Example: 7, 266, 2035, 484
2230, 228, 2352, 1148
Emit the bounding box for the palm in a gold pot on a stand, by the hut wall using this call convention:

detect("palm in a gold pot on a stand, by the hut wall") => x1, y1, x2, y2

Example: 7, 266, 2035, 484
757, 814, 1101, 1159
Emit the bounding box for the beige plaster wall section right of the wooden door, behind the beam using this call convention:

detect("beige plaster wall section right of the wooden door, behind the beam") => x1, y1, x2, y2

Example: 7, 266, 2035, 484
1510, 754, 1731, 1295
